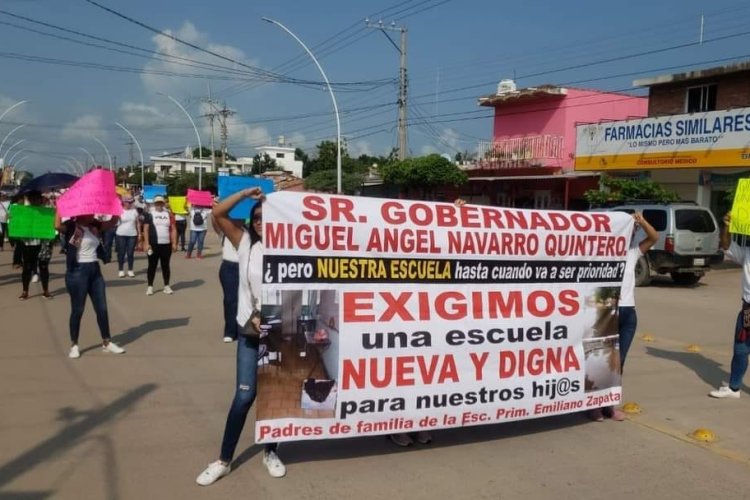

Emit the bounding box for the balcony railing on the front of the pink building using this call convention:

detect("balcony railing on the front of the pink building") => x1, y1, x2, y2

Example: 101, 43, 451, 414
477, 135, 563, 169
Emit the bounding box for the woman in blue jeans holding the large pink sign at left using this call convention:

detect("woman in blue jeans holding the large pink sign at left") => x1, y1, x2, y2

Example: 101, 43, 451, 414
55, 213, 125, 359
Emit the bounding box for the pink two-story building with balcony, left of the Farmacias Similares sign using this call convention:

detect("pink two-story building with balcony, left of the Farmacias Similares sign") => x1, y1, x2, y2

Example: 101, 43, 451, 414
472, 84, 648, 209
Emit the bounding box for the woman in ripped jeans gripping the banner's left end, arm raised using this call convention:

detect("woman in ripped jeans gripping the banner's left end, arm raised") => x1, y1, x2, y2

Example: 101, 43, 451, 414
196, 188, 286, 486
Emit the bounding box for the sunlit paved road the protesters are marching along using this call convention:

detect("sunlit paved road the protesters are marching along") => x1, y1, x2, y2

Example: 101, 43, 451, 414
0, 239, 750, 500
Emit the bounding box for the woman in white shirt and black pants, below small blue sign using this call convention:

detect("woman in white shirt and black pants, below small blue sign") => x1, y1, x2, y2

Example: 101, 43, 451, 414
143, 196, 177, 295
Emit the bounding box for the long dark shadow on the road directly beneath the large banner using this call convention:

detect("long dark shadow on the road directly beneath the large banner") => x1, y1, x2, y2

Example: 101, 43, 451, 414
253, 411, 592, 467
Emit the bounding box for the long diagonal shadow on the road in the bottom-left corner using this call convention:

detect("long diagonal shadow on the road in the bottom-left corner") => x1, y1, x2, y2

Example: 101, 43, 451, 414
0, 384, 158, 492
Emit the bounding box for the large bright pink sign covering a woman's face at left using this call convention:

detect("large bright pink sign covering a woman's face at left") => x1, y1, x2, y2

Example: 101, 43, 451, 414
57, 169, 122, 217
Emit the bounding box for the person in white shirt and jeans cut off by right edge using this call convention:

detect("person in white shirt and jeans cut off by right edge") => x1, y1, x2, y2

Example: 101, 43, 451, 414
708, 214, 750, 399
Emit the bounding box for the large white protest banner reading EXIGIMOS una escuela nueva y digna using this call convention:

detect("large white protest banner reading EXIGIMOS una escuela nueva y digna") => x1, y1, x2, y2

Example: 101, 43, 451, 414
255, 192, 633, 443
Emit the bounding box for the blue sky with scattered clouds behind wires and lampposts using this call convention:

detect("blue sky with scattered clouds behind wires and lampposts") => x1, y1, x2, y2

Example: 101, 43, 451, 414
0, 0, 750, 173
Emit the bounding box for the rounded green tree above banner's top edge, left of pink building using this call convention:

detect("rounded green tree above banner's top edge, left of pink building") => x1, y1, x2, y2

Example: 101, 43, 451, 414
380, 154, 468, 199
